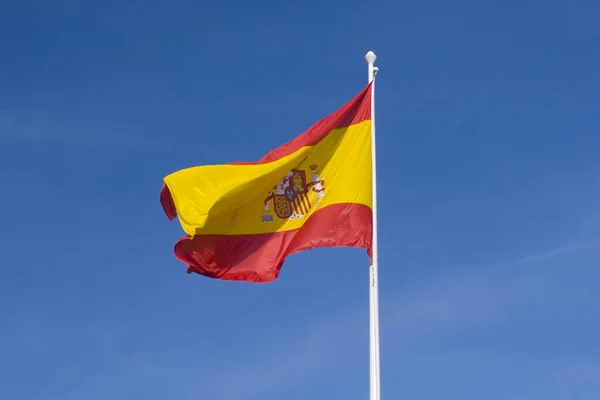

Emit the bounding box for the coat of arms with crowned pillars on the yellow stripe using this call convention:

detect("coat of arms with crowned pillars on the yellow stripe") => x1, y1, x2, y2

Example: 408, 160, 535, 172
261, 164, 325, 222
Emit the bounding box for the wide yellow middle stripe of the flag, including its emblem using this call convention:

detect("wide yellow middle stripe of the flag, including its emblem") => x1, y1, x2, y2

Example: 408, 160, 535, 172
164, 120, 372, 236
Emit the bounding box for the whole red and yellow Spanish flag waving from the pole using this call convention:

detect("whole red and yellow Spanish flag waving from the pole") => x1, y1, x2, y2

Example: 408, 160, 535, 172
160, 83, 372, 282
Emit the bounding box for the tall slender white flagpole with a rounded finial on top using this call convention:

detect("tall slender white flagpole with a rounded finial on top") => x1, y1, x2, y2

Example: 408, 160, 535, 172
365, 51, 381, 400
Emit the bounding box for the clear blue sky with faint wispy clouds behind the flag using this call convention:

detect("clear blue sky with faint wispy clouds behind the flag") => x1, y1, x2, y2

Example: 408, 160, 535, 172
0, 0, 600, 400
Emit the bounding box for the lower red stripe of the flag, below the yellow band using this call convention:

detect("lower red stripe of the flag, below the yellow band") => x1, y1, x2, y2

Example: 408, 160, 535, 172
175, 203, 372, 282
